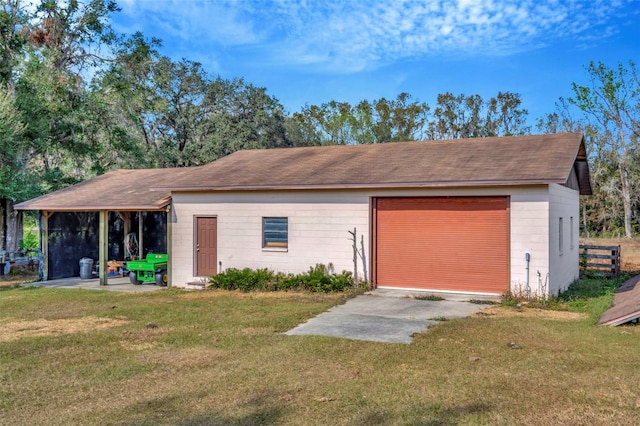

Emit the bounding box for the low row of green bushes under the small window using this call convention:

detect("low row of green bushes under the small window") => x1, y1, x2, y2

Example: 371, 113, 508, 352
209, 263, 354, 293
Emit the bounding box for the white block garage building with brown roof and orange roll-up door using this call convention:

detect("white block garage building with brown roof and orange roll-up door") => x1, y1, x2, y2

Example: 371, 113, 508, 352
18, 133, 591, 295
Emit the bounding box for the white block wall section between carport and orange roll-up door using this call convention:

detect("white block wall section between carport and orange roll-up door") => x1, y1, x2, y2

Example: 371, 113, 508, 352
172, 191, 369, 287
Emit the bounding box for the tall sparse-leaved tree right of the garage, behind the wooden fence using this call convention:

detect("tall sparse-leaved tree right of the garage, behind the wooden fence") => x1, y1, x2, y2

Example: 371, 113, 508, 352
569, 62, 640, 238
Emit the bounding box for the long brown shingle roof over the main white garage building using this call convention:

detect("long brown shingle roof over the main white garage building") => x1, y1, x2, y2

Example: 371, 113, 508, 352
163, 133, 591, 194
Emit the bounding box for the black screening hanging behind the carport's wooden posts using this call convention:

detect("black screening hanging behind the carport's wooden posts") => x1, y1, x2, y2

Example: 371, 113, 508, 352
47, 212, 167, 280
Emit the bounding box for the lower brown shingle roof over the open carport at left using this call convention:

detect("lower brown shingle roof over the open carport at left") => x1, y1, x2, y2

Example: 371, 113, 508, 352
15, 167, 197, 211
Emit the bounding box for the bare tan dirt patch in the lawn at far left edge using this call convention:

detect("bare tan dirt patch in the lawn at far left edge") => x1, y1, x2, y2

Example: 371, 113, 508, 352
0, 317, 130, 342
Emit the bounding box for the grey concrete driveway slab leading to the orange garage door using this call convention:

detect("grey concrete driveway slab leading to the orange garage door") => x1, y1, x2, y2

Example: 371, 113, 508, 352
285, 290, 489, 343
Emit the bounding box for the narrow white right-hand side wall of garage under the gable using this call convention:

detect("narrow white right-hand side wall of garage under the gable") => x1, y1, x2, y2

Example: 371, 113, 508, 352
549, 184, 580, 295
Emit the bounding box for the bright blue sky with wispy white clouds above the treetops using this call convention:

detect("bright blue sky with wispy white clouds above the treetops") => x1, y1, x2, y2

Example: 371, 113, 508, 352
113, 0, 640, 125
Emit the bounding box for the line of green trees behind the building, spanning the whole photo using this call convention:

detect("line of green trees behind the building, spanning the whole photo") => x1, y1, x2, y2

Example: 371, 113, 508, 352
0, 0, 640, 251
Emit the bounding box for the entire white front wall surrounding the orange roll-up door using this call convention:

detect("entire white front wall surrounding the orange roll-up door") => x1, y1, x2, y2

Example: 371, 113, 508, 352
172, 185, 556, 291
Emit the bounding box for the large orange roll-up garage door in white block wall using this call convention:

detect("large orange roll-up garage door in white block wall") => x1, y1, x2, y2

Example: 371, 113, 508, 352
373, 197, 510, 293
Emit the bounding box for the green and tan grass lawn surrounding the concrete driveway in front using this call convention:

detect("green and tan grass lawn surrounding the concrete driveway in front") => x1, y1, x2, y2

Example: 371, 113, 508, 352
0, 282, 640, 425
